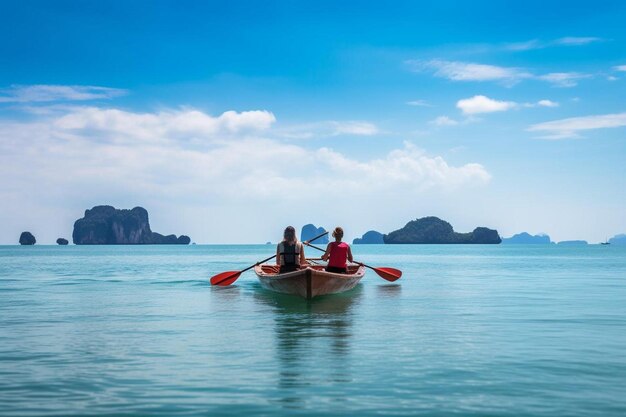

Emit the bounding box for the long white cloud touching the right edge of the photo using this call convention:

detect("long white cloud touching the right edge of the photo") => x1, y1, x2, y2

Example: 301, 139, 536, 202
527, 113, 626, 139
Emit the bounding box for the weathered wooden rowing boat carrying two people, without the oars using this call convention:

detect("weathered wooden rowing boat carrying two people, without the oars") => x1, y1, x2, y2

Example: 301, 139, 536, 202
254, 264, 365, 300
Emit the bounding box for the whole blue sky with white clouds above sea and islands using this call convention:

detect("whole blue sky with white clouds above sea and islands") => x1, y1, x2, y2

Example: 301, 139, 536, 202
0, 0, 626, 244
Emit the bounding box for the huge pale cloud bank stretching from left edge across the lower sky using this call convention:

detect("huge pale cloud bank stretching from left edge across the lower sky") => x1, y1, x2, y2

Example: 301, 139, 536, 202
0, 106, 491, 242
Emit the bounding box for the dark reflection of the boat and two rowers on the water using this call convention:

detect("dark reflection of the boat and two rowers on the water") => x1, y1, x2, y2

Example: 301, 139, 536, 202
254, 285, 363, 408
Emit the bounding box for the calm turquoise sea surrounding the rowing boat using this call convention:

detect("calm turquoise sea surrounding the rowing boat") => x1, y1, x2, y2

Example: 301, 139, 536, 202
0, 245, 626, 417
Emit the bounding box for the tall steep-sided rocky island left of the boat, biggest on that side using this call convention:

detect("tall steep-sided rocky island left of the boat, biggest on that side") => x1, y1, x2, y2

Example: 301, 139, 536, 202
72, 206, 191, 245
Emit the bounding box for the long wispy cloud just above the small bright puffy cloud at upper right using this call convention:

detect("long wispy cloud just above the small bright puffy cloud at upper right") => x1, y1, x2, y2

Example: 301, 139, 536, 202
407, 59, 532, 85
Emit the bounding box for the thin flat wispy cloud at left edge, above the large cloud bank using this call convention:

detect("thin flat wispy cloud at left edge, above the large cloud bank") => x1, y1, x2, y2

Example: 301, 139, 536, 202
0, 85, 127, 103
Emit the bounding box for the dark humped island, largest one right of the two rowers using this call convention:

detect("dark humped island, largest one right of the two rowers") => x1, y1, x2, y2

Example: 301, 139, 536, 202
383, 216, 502, 244
